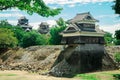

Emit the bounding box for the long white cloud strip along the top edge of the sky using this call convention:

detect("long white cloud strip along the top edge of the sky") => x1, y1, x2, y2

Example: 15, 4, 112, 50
44, 0, 113, 5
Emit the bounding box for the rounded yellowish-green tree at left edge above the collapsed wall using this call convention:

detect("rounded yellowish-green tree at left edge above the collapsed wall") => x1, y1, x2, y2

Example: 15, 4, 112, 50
0, 28, 18, 48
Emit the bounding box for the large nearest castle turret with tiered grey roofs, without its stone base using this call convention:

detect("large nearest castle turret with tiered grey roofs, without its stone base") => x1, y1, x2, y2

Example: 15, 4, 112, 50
61, 12, 104, 44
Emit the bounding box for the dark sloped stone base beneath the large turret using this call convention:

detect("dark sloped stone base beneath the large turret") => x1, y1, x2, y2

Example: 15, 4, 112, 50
50, 44, 116, 76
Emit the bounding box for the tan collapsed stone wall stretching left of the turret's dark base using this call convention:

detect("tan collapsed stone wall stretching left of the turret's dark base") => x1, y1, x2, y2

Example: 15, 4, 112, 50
0, 46, 62, 73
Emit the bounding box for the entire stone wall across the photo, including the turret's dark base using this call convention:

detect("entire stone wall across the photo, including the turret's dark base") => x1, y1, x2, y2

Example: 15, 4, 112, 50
0, 44, 120, 76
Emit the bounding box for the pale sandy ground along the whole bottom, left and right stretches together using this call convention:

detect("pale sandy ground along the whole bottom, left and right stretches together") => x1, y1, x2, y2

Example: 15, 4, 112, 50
0, 70, 120, 80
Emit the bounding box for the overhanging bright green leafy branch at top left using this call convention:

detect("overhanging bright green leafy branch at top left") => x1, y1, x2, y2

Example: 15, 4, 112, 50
0, 0, 62, 17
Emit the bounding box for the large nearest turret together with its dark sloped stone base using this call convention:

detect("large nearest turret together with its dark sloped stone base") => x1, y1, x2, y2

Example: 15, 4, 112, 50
51, 12, 105, 76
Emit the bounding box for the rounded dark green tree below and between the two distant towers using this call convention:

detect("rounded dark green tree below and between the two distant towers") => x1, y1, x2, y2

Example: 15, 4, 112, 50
21, 31, 46, 47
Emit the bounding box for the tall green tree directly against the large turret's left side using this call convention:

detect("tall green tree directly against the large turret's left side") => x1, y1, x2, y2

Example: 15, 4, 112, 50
49, 18, 66, 45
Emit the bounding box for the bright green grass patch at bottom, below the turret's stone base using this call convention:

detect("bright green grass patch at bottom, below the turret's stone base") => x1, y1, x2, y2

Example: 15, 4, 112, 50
76, 74, 100, 80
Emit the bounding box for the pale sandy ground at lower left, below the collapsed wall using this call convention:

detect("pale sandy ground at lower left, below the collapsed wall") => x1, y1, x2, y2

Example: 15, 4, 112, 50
0, 71, 80, 80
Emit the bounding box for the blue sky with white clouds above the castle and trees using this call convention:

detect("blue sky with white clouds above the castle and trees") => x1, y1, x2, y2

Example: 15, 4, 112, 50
0, 0, 120, 34
